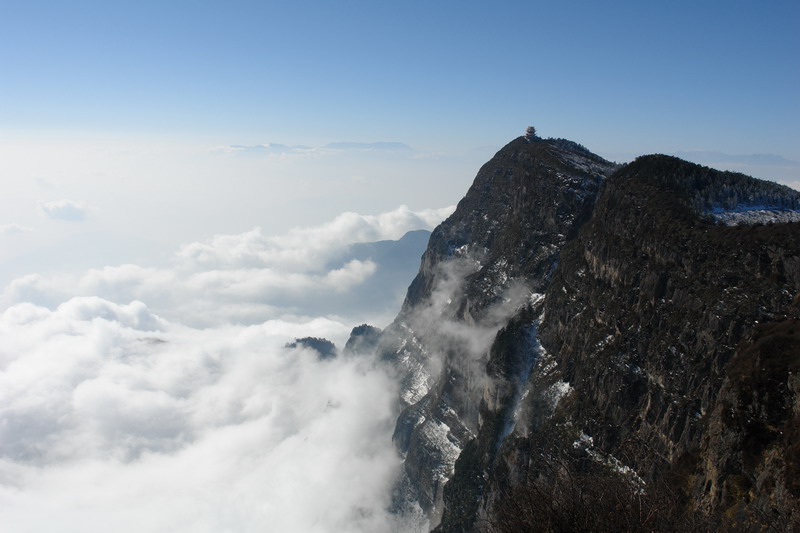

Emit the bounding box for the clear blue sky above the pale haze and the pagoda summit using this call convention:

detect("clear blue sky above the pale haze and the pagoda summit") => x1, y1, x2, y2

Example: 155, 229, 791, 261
0, 1, 800, 155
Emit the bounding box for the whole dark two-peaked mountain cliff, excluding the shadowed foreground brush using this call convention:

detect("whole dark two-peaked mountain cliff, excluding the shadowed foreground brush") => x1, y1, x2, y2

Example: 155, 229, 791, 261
372, 138, 800, 531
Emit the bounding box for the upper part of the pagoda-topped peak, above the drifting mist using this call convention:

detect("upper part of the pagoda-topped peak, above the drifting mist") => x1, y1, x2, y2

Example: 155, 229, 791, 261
401, 137, 617, 317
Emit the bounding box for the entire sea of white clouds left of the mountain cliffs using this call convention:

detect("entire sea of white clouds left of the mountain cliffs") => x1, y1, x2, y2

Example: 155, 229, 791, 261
0, 208, 453, 533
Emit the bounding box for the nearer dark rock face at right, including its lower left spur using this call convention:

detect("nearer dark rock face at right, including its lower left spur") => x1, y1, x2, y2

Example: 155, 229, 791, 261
438, 156, 800, 531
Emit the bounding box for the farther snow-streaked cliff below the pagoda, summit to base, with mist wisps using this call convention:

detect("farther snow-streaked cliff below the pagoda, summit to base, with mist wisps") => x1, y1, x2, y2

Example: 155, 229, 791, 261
382, 138, 616, 525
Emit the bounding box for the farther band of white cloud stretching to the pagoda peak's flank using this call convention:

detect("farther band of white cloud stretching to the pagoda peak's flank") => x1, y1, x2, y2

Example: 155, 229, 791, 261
0, 206, 453, 326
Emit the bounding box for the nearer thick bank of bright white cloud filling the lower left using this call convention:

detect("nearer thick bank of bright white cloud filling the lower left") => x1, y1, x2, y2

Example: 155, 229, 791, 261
0, 298, 399, 533
